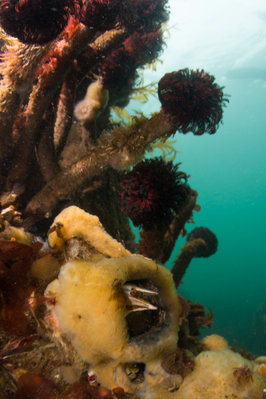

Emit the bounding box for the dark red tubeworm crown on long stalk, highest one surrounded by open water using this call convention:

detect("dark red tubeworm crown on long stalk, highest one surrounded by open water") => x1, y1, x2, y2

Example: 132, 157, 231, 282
158, 68, 228, 135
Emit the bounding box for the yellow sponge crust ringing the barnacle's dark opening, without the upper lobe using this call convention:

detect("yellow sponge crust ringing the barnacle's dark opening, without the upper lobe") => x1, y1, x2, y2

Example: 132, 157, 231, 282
45, 255, 179, 364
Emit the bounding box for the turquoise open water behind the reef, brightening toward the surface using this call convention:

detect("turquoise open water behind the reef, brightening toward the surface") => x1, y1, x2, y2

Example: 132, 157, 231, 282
129, 0, 266, 354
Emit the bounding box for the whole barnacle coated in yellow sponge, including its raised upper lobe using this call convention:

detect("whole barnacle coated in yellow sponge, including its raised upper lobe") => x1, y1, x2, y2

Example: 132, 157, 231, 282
45, 207, 179, 365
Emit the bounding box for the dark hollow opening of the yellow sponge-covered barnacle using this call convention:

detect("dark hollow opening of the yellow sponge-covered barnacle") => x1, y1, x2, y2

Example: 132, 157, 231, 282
124, 279, 167, 340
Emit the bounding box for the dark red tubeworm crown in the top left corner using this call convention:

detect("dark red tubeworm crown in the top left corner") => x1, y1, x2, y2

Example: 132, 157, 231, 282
0, 0, 71, 44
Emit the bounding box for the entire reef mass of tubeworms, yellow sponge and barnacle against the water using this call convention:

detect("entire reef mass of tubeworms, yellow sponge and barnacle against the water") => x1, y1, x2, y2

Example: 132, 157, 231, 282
0, 0, 266, 399
